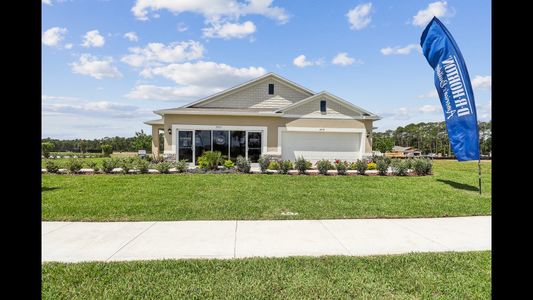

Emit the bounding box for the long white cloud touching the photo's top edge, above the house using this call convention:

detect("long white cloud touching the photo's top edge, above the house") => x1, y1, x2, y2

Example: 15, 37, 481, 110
131, 0, 289, 23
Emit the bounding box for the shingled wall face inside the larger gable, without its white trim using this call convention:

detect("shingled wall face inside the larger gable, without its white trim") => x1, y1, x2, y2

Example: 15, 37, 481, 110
195, 78, 309, 109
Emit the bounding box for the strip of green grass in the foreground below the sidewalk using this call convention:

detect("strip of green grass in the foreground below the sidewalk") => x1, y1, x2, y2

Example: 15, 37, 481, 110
42, 251, 492, 299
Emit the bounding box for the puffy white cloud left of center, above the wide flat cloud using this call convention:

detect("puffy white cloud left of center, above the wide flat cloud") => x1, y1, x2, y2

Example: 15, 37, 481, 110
121, 40, 205, 67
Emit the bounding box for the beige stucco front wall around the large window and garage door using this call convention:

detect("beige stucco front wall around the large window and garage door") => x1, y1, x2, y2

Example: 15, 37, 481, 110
163, 115, 372, 153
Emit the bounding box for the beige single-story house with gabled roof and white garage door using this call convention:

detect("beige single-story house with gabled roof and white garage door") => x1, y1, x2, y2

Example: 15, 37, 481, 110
145, 73, 380, 162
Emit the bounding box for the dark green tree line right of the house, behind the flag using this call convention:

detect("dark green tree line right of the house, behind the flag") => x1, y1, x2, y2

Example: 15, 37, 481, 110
372, 121, 492, 156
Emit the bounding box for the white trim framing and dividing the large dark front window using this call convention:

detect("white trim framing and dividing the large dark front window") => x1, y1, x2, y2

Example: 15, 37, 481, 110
172, 124, 268, 163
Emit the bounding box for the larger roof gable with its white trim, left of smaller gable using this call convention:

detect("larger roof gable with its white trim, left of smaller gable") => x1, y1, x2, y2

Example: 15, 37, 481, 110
183, 73, 314, 110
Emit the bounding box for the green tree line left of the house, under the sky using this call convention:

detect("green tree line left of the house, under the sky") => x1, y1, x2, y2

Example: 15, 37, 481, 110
42, 130, 152, 153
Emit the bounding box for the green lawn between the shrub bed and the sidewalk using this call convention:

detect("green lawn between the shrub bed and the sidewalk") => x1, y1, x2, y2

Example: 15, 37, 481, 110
42, 161, 491, 221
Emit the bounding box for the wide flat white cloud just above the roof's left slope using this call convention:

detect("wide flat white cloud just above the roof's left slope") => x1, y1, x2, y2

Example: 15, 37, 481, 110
141, 61, 266, 88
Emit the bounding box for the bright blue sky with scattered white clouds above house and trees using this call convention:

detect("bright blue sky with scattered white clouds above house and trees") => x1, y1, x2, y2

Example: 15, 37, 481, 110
42, 0, 491, 139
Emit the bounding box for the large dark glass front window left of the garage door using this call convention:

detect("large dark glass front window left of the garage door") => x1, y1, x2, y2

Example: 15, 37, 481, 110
177, 130, 263, 163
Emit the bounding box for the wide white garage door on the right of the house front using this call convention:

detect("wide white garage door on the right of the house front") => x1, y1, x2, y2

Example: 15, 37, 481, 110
281, 131, 361, 163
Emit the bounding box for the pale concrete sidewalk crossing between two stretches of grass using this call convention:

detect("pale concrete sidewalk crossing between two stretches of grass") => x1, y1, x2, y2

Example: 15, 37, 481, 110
42, 216, 491, 262
